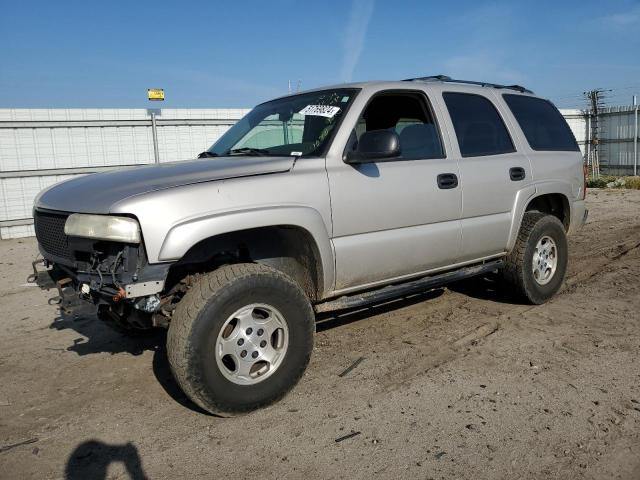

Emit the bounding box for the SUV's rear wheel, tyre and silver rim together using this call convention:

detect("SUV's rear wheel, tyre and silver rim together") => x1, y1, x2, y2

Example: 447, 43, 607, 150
503, 212, 569, 305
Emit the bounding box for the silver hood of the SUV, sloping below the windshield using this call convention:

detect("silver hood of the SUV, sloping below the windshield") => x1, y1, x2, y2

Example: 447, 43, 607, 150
35, 156, 295, 213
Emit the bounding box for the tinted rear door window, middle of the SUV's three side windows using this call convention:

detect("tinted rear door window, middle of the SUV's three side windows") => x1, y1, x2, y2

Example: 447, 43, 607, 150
442, 92, 515, 157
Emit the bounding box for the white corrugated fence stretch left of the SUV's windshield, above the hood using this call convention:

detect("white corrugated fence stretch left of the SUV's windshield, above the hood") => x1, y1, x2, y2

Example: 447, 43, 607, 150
0, 109, 248, 238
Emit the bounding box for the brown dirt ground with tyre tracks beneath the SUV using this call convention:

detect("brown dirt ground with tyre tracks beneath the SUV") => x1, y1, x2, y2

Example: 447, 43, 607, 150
0, 190, 640, 480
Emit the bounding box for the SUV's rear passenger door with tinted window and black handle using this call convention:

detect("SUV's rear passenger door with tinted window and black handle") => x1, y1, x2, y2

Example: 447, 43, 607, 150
442, 92, 531, 261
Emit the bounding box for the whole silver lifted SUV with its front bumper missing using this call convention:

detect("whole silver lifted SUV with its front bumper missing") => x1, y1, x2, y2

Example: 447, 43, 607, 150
34, 76, 587, 415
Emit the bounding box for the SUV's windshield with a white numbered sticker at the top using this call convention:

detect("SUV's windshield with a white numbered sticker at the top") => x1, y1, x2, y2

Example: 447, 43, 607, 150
205, 88, 357, 156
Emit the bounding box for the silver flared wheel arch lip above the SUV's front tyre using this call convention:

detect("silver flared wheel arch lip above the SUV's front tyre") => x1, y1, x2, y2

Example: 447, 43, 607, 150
158, 206, 335, 292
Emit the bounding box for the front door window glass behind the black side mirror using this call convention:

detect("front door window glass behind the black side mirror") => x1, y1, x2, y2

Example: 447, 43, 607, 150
355, 93, 444, 160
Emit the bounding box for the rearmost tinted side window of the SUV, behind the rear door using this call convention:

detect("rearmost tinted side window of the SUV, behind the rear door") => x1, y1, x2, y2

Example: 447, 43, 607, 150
503, 95, 579, 151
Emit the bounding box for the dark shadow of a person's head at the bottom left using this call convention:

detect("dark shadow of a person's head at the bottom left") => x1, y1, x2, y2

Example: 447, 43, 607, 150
64, 440, 149, 480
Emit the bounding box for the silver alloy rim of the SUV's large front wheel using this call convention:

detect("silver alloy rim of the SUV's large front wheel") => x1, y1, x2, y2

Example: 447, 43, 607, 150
215, 303, 289, 385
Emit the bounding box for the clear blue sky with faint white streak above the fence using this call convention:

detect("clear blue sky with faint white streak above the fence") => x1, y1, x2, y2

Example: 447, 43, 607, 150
0, 0, 640, 108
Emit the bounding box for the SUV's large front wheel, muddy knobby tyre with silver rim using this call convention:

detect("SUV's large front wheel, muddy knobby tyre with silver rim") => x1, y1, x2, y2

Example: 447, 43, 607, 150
167, 264, 315, 416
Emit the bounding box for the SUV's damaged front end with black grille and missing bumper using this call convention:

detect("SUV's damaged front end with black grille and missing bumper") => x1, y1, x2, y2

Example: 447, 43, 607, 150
28, 208, 184, 330
